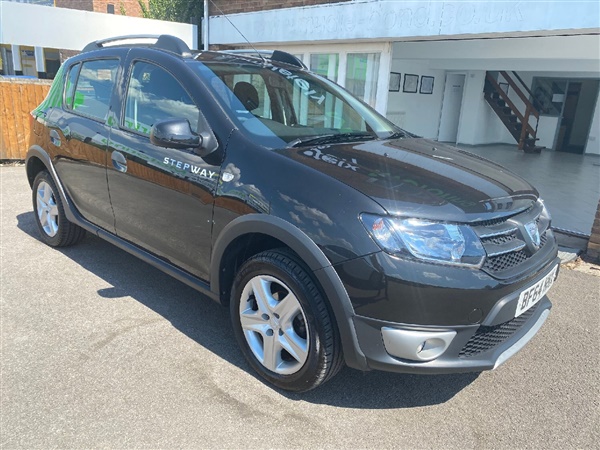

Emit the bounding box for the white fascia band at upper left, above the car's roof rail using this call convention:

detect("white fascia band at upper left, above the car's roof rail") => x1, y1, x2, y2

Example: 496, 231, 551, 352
0, 1, 198, 50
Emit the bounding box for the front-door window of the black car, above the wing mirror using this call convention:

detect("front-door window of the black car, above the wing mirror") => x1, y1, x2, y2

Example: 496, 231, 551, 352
123, 61, 200, 135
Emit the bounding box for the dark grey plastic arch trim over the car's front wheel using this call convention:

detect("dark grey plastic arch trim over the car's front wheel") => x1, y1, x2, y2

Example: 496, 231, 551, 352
210, 214, 369, 370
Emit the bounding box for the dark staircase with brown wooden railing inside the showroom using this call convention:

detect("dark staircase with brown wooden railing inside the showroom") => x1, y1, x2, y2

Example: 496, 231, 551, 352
486, 71, 540, 150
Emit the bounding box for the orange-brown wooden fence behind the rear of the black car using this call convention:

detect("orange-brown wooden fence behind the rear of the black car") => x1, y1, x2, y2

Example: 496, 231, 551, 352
0, 78, 52, 160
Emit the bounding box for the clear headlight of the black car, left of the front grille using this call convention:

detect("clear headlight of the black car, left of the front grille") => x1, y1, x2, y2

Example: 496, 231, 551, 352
360, 214, 485, 268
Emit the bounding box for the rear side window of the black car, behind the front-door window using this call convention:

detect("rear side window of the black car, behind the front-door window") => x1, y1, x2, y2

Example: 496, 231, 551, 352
66, 59, 119, 121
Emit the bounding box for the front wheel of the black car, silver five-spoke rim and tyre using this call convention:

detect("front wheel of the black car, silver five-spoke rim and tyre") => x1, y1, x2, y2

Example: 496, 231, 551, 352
230, 249, 342, 392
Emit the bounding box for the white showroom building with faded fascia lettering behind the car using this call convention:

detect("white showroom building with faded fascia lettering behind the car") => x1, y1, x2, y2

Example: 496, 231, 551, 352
209, 0, 600, 155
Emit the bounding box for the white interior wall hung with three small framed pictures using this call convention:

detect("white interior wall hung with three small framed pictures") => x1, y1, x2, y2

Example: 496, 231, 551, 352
387, 59, 445, 139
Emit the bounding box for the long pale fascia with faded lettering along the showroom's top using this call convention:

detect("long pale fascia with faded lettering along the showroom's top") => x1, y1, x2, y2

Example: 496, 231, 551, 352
209, 0, 600, 44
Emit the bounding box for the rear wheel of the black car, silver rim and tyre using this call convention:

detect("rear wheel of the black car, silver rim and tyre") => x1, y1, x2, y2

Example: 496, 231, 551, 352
32, 170, 85, 247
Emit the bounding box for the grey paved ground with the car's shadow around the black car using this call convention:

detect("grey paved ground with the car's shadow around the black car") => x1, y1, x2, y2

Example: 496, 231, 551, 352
0, 167, 600, 449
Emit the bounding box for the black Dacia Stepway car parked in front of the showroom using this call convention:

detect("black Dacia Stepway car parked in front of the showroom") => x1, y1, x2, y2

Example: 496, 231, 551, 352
27, 35, 559, 391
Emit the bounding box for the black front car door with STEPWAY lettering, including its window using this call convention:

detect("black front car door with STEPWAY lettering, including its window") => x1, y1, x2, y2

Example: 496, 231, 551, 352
108, 61, 220, 280
